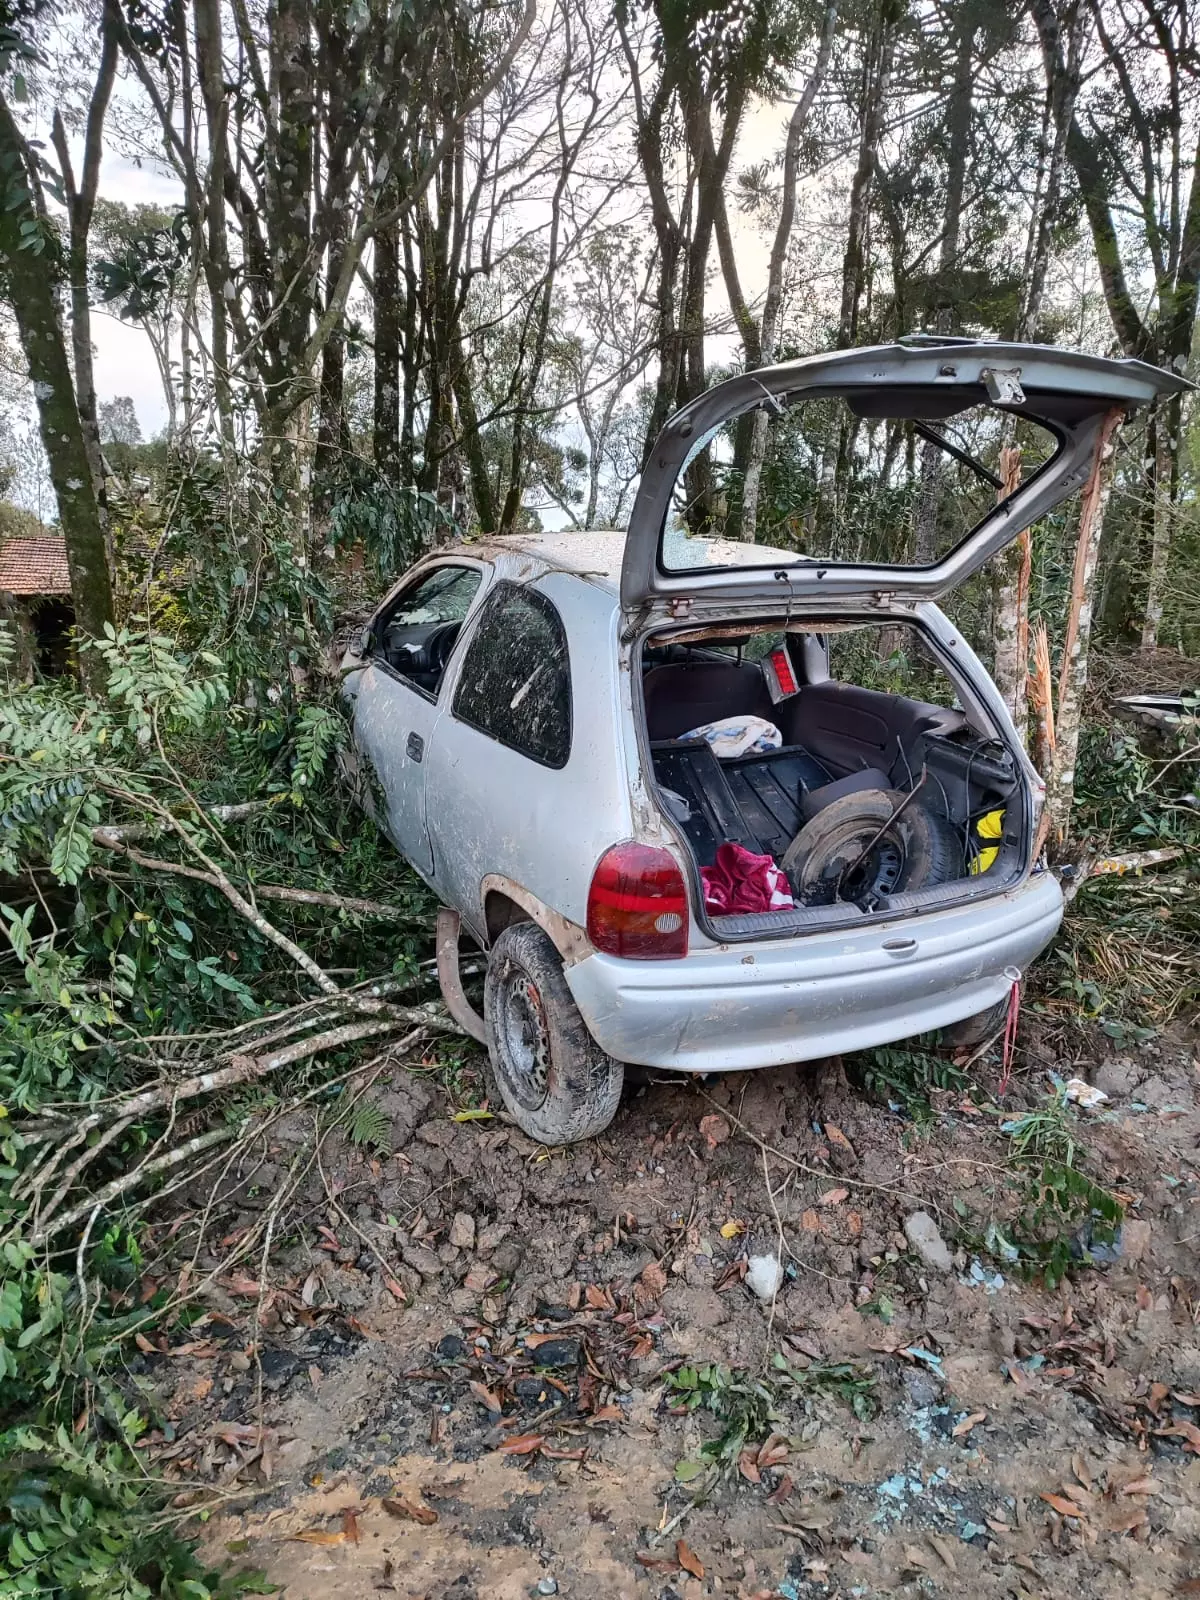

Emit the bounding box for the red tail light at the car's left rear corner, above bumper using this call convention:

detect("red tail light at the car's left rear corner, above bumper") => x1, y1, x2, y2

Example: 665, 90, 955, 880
587, 840, 688, 962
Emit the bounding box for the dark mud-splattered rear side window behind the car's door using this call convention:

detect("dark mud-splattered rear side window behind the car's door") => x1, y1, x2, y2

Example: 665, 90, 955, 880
454, 584, 571, 768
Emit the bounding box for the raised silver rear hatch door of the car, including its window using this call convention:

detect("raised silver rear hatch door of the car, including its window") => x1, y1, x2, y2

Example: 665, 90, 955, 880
621, 334, 1192, 622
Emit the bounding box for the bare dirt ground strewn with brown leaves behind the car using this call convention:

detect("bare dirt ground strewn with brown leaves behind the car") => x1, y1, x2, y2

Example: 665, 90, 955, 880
142, 1016, 1200, 1600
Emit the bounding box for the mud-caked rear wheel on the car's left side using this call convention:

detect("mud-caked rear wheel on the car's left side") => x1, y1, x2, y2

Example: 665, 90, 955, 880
483, 922, 624, 1144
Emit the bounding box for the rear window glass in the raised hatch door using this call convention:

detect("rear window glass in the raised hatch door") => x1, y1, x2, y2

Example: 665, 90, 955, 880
659, 392, 1059, 573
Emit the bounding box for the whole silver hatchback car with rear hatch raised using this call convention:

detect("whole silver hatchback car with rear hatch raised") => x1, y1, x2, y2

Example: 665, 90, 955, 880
342, 338, 1186, 1144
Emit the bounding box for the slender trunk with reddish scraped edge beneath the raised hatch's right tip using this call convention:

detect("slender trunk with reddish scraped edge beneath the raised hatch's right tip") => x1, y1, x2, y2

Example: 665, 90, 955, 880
1046, 408, 1123, 850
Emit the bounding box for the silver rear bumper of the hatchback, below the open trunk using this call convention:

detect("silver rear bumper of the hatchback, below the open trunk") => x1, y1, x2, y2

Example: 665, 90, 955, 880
566, 872, 1062, 1072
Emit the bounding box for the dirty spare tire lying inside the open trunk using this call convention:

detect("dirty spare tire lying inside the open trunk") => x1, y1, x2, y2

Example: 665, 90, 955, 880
779, 789, 965, 906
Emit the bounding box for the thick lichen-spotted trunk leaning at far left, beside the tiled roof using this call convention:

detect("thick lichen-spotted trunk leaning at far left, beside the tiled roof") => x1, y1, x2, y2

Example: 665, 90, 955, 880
0, 94, 114, 686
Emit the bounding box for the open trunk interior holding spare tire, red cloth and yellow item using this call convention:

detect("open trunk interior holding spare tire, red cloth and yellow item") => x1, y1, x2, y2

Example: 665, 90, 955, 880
642, 621, 1030, 938
